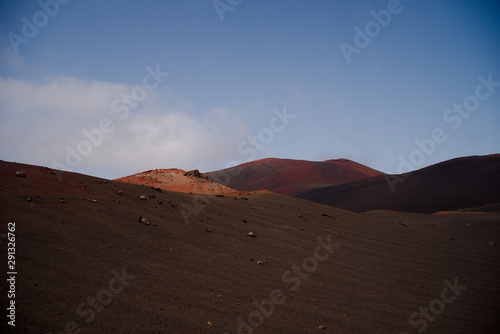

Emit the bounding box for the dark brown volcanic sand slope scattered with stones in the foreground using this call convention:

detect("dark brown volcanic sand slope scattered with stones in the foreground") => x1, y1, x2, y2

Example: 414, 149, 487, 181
0, 162, 500, 334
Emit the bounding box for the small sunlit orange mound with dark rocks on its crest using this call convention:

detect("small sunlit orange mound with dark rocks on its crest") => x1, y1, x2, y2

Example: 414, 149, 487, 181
115, 168, 238, 195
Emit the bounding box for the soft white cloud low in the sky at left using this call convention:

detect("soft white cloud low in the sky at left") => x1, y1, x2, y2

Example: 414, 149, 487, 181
0, 77, 250, 177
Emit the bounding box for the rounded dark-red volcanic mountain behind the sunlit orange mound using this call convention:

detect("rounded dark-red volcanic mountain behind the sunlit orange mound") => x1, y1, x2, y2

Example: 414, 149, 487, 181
205, 158, 384, 196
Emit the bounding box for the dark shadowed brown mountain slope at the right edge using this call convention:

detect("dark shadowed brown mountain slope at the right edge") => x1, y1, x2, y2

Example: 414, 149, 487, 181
298, 154, 500, 213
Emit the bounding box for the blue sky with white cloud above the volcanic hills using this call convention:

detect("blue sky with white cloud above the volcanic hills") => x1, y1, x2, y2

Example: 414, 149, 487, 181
0, 0, 500, 178
